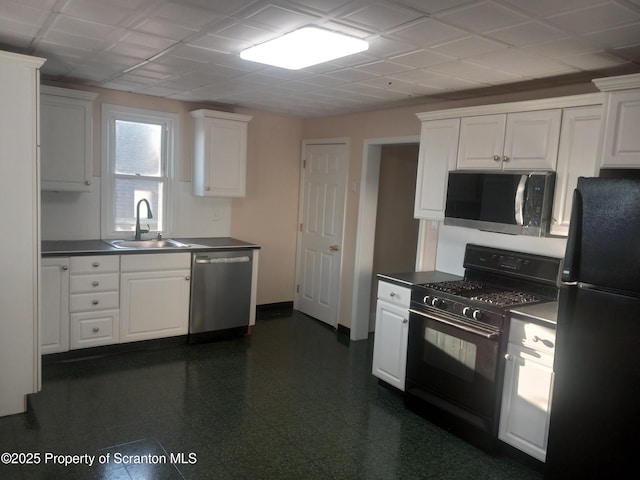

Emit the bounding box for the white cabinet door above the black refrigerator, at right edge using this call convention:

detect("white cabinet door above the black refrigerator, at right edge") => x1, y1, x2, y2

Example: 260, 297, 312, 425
601, 89, 640, 168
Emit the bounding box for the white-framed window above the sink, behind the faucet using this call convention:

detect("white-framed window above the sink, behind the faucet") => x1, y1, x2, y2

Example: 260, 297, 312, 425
102, 104, 179, 238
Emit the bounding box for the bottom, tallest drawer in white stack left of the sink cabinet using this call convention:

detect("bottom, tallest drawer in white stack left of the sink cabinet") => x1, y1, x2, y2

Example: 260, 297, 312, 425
71, 310, 120, 349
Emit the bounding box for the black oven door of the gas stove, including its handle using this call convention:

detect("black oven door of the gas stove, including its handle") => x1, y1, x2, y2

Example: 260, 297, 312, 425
406, 309, 500, 424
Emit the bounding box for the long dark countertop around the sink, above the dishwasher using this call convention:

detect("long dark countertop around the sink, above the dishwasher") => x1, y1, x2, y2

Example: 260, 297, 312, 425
41, 237, 260, 257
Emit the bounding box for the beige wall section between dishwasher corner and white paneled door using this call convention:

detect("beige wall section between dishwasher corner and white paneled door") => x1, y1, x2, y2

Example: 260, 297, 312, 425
231, 110, 302, 305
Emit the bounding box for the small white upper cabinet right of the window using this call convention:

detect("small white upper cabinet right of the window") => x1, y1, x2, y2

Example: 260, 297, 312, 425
191, 110, 251, 197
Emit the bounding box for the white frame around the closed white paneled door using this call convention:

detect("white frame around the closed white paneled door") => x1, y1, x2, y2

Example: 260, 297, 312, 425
293, 137, 351, 328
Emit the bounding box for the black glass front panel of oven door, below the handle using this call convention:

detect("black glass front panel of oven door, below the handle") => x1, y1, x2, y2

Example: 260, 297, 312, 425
407, 313, 499, 416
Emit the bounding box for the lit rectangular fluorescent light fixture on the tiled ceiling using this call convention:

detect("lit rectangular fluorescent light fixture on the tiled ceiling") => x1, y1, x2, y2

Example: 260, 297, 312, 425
240, 27, 369, 70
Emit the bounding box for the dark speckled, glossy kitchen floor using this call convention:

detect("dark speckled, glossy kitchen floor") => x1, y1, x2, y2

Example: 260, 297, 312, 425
0, 312, 542, 480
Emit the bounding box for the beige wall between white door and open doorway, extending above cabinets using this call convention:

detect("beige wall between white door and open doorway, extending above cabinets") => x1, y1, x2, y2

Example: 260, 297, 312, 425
302, 82, 597, 328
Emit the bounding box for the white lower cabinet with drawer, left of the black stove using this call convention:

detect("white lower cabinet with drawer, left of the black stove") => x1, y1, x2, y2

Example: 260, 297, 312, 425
372, 282, 411, 391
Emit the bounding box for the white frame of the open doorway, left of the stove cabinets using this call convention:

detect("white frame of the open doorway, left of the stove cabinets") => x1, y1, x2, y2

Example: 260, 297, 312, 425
350, 135, 437, 340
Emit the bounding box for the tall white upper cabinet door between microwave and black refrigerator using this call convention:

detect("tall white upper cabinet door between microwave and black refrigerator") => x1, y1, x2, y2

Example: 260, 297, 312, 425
551, 105, 602, 236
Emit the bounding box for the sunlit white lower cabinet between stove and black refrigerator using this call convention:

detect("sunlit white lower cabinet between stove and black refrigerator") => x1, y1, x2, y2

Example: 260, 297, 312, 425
498, 318, 555, 462
